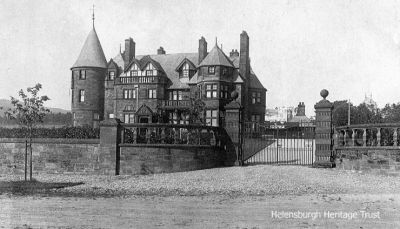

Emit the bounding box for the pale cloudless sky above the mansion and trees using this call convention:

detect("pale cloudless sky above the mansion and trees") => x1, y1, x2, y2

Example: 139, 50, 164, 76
0, 0, 400, 115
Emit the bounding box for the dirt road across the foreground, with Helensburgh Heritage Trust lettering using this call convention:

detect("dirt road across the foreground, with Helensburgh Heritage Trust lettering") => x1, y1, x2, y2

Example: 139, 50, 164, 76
0, 194, 400, 228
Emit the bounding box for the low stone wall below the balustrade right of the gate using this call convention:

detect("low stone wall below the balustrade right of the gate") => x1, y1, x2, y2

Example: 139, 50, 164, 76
335, 146, 400, 176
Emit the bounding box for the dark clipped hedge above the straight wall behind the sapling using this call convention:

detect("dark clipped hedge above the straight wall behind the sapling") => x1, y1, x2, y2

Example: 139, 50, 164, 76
0, 127, 100, 139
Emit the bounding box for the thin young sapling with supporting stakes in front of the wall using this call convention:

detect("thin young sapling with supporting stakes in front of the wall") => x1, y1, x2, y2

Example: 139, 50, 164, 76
4, 83, 50, 180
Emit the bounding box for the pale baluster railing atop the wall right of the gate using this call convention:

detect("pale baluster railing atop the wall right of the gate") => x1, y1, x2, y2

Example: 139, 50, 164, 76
334, 123, 400, 147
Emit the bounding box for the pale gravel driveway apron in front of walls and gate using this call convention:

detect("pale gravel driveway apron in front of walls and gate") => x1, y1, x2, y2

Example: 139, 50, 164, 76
0, 165, 400, 197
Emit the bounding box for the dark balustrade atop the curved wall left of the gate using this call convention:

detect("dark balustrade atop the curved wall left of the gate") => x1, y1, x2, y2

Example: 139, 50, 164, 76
120, 123, 227, 146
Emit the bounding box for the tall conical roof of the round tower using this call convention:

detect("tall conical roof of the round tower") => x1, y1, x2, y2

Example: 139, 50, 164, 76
72, 27, 107, 68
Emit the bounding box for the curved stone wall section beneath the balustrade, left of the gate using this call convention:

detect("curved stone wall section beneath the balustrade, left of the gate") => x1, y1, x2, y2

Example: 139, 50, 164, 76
120, 144, 225, 175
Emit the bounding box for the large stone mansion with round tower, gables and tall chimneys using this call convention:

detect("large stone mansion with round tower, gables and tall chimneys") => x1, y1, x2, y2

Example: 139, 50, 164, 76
71, 22, 266, 127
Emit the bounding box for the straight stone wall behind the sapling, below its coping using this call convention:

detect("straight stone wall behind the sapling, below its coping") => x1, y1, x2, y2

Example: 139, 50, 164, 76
0, 138, 115, 174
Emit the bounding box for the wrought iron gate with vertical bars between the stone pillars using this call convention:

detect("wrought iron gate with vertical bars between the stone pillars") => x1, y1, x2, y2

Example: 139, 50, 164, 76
242, 123, 315, 165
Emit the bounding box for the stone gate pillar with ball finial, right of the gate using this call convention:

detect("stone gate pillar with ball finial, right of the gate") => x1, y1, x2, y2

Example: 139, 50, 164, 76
314, 89, 335, 168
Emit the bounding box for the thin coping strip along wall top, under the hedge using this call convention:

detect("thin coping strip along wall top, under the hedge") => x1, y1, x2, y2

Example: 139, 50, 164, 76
0, 138, 100, 144
